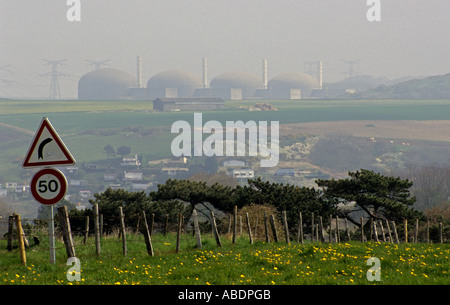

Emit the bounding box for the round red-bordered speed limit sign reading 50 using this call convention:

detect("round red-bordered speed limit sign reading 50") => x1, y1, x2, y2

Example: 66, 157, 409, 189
30, 168, 67, 205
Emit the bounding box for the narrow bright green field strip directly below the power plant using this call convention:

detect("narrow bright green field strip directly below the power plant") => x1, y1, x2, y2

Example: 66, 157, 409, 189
0, 100, 450, 127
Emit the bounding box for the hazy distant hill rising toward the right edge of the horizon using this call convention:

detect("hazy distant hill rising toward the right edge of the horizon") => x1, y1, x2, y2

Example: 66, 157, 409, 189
345, 73, 450, 99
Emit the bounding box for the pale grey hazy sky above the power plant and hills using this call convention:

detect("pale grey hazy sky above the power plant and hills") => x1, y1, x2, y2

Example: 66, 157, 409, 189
0, 0, 450, 98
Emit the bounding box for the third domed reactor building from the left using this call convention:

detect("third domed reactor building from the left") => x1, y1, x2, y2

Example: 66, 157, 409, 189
210, 71, 263, 100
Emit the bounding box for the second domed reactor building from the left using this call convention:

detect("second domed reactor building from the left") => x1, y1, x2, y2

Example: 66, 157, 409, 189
147, 70, 203, 100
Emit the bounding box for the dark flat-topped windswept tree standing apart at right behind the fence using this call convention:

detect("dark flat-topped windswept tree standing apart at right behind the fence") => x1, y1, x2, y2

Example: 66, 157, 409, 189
316, 169, 422, 225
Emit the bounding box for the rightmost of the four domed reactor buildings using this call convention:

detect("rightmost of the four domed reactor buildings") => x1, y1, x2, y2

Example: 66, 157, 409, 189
268, 72, 320, 100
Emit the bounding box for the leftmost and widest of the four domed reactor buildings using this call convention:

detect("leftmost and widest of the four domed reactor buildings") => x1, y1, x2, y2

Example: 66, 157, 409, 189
78, 68, 137, 100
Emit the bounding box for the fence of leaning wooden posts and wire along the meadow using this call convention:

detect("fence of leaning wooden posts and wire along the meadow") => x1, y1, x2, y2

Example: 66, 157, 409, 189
0, 206, 448, 265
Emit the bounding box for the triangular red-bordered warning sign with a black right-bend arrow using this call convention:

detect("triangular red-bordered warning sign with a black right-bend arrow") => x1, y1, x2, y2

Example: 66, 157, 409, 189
22, 118, 76, 167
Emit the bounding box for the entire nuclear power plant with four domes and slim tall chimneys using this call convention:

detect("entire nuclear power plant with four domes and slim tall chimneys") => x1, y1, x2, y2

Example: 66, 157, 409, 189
78, 56, 324, 100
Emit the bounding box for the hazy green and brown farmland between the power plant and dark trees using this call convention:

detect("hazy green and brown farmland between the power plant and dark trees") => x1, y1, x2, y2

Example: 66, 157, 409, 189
0, 100, 450, 217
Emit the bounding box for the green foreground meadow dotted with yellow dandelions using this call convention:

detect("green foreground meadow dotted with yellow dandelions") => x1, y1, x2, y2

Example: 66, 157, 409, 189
0, 233, 450, 285
